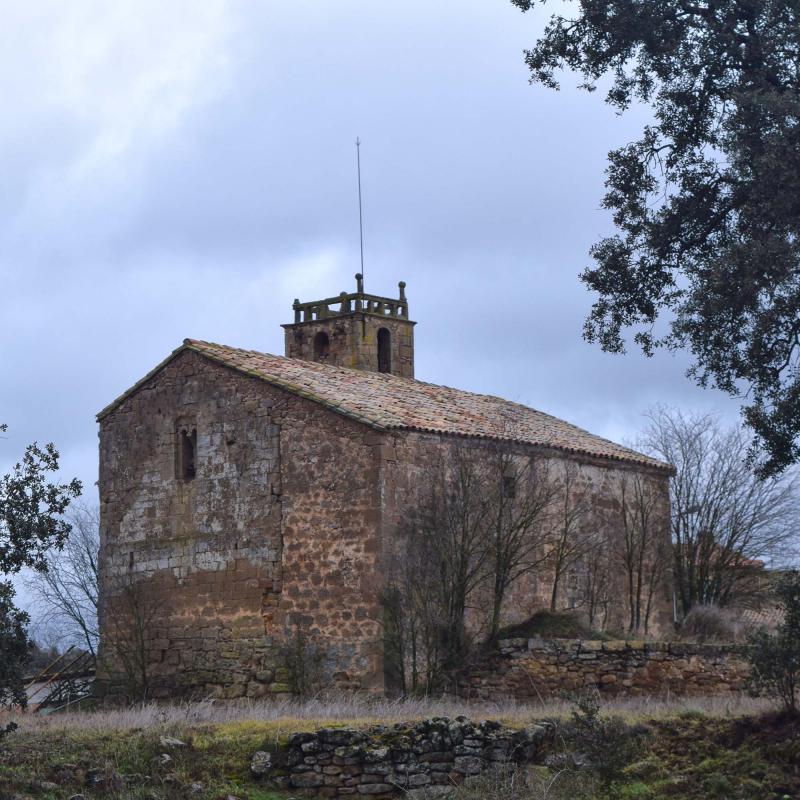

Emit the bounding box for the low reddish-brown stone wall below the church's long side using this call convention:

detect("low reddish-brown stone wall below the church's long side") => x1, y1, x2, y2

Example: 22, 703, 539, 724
457, 639, 748, 701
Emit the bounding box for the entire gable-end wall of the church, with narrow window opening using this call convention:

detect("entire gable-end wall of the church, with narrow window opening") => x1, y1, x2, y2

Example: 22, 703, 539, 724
99, 352, 382, 697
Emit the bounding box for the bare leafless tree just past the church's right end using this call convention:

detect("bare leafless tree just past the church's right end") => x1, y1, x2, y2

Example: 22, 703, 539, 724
640, 407, 800, 615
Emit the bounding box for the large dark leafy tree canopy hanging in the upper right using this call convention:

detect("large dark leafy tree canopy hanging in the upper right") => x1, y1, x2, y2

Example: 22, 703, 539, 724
512, 0, 800, 474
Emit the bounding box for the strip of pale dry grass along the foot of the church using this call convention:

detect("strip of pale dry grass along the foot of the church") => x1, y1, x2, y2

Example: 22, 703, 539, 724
0, 693, 773, 733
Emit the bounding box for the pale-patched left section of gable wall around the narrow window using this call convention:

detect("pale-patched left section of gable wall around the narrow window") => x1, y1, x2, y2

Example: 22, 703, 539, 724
99, 353, 281, 696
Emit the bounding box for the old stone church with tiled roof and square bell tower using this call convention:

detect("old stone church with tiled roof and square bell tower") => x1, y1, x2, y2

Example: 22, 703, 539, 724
98, 275, 671, 698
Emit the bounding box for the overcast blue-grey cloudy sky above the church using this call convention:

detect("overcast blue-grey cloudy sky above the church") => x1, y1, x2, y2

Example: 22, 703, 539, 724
0, 0, 736, 544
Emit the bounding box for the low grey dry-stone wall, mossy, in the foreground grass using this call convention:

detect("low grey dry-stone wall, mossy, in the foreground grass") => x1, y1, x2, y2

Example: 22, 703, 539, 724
251, 717, 555, 800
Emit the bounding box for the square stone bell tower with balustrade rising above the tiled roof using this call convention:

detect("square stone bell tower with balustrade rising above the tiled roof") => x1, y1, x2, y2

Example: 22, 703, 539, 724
282, 273, 416, 378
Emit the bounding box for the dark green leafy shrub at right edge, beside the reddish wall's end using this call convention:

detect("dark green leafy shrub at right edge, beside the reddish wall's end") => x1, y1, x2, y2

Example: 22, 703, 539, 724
748, 570, 800, 714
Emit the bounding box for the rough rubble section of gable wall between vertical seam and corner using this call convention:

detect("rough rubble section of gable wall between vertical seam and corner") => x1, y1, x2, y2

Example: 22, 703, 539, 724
274, 378, 383, 691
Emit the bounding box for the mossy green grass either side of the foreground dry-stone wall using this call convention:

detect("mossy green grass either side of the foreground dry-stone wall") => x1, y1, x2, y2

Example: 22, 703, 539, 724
0, 714, 800, 800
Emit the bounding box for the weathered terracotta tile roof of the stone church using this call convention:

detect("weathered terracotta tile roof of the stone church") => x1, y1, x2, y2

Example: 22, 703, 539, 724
98, 339, 672, 471
